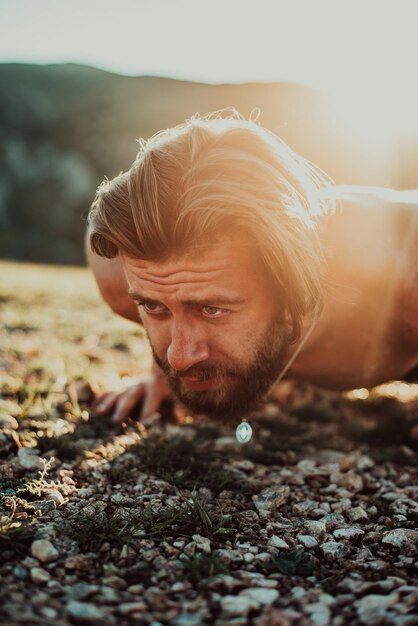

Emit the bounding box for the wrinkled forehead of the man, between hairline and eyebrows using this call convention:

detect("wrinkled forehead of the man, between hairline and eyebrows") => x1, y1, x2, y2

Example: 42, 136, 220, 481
122, 236, 267, 292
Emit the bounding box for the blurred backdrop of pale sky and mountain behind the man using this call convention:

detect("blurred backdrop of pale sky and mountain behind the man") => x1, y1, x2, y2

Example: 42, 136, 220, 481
0, 0, 418, 265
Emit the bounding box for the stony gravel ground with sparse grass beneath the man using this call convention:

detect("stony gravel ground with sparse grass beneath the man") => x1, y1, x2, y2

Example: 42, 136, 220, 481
0, 260, 418, 626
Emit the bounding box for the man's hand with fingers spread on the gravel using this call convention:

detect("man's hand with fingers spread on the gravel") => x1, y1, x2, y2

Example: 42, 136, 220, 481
93, 366, 171, 423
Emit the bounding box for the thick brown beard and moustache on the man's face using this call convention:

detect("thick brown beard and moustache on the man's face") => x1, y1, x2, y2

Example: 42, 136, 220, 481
150, 317, 290, 421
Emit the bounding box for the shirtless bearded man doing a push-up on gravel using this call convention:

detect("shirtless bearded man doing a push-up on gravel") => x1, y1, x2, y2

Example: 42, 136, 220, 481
86, 114, 418, 421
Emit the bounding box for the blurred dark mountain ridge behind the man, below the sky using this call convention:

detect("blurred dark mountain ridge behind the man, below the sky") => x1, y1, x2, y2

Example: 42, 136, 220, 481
0, 64, 418, 264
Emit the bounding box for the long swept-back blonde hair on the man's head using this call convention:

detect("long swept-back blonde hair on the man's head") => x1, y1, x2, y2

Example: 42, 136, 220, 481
88, 109, 332, 341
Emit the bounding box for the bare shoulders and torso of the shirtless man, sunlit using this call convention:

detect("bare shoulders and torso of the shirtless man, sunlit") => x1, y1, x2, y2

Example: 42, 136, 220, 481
86, 187, 418, 420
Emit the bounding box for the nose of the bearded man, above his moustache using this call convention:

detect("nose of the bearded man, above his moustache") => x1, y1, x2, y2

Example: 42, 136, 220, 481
167, 324, 210, 371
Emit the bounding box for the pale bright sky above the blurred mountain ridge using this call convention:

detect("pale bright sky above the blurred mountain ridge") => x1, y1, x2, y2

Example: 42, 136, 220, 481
0, 0, 418, 130
